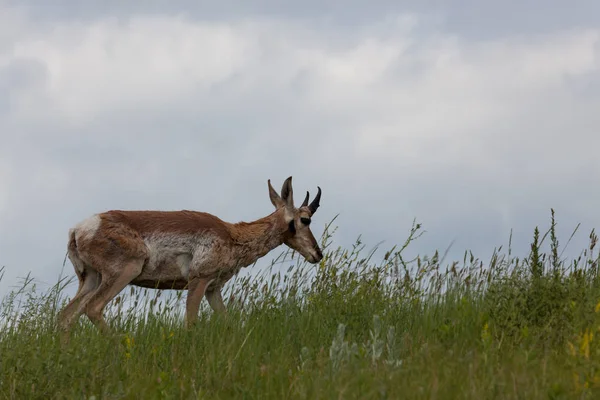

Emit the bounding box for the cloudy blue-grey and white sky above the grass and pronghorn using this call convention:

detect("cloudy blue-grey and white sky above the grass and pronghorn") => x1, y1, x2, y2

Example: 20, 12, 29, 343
0, 0, 600, 296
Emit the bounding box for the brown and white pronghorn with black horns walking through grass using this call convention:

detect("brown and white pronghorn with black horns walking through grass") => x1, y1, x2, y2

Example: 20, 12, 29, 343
59, 176, 323, 332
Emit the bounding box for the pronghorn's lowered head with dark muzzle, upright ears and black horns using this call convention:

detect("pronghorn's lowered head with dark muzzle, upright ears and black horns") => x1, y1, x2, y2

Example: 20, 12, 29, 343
268, 176, 323, 264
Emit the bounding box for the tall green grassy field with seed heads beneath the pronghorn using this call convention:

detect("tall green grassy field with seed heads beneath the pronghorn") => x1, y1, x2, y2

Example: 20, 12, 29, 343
0, 214, 600, 399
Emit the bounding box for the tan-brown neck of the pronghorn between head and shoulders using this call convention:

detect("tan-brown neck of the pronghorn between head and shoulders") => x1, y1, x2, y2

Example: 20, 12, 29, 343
231, 209, 287, 265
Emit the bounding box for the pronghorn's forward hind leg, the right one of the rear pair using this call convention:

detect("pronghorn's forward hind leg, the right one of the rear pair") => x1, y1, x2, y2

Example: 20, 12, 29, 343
85, 259, 145, 333
